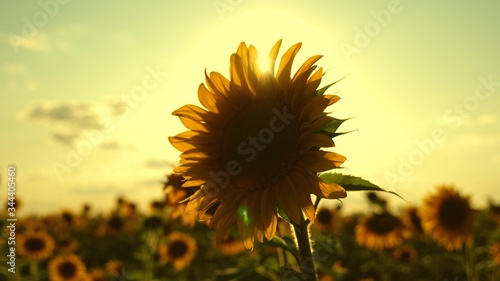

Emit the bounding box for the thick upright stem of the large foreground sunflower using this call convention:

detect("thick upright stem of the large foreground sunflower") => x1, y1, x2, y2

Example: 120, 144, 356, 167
293, 213, 318, 281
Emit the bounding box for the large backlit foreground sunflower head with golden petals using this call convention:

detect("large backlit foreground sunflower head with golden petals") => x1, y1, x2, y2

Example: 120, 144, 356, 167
170, 40, 346, 249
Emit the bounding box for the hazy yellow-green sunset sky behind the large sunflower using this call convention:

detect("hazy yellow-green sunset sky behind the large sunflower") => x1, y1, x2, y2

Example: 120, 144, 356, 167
0, 0, 500, 214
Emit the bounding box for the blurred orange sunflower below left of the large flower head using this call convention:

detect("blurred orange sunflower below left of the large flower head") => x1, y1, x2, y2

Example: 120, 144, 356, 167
158, 232, 197, 270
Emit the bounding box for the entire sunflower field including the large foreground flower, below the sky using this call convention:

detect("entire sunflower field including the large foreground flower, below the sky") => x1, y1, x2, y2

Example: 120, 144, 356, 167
0, 40, 500, 281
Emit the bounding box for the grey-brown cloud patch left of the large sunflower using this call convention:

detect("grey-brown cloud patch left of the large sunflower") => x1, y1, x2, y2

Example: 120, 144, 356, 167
18, 100, 130, 149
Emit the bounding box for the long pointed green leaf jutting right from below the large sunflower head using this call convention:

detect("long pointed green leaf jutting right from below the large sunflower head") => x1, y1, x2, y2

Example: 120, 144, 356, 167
319, 173, 406, 201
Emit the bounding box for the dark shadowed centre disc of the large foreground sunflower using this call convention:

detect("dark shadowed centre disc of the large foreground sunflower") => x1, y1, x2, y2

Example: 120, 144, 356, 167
221, 99, 300, 190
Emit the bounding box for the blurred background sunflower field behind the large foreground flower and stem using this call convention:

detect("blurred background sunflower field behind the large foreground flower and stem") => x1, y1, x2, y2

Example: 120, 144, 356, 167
0, 178, 500, 281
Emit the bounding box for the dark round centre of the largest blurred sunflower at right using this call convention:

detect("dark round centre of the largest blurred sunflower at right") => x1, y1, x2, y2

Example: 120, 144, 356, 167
438, 197, 469, 230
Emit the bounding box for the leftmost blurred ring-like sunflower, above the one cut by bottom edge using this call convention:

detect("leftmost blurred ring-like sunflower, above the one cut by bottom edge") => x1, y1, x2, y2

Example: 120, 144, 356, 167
17, 231, 55, 261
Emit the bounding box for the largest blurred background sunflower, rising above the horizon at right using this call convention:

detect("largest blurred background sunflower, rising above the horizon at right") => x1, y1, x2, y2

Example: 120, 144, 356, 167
420, 185, 475, 251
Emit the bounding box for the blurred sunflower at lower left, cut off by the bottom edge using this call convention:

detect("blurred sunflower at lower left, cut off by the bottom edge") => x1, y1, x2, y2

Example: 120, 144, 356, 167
48, 254, 87, 281
